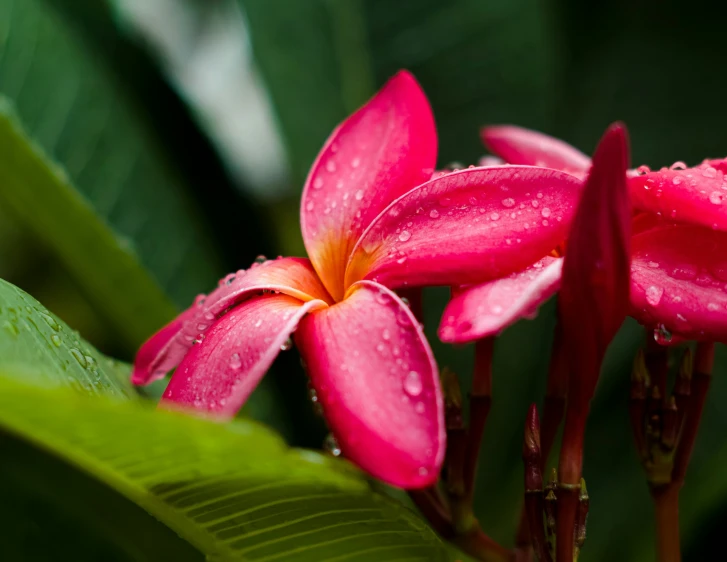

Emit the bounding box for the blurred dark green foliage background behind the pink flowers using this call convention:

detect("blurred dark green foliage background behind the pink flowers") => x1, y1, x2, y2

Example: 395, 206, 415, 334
0, 0, 727, 562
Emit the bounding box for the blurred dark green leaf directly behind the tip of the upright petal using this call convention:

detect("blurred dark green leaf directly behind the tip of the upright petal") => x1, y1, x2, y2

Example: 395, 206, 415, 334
239, 0, 555, 180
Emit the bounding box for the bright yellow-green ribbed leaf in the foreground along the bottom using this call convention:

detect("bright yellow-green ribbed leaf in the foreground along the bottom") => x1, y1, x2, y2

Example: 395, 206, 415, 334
0, 378, 449, 562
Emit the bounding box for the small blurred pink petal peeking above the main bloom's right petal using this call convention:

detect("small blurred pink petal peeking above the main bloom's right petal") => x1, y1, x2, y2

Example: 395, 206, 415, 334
482, 125, 591, 178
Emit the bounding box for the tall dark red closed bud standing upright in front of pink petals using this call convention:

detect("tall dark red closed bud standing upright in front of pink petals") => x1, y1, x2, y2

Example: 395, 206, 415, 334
558, 124, 632, 398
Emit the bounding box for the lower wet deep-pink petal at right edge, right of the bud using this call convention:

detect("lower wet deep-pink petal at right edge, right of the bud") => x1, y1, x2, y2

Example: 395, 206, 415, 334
631, 225, 727, 341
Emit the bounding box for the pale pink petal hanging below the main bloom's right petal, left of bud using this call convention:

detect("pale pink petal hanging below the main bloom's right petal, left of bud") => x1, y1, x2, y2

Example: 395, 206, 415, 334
439, 257, 563, 343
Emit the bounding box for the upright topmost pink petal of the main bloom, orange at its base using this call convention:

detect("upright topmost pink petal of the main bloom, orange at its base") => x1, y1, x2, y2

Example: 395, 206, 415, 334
300, 71, 437, 300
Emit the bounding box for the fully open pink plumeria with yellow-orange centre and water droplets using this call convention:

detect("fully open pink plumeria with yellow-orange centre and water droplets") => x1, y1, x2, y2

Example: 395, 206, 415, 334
133, 72, 578, 488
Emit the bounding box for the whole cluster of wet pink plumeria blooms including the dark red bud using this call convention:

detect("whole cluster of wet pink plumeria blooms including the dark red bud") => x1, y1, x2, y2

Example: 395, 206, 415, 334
132, 72, 727, 560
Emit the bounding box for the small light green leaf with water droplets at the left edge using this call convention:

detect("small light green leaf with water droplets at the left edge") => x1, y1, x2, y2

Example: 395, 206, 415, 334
0, 279, 136, 398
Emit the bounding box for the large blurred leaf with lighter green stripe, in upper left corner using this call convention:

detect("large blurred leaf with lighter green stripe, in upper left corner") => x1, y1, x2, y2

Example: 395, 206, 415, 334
0, 0, 225, 345
